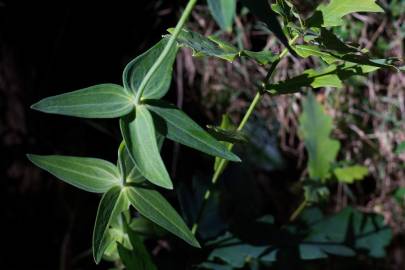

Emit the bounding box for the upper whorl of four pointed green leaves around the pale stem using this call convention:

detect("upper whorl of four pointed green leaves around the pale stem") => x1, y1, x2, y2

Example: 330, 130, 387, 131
32, 38, 240, 189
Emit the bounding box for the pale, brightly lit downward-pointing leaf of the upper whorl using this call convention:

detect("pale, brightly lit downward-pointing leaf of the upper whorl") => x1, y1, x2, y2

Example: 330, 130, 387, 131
120, 105, 173, 189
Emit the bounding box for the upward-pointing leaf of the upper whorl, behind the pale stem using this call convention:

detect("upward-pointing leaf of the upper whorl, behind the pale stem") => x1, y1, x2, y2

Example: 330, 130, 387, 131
122, 38, 178, 99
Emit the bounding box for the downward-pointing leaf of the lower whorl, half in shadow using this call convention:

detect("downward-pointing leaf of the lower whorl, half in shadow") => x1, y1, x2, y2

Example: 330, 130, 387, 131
93, 186, 128, 264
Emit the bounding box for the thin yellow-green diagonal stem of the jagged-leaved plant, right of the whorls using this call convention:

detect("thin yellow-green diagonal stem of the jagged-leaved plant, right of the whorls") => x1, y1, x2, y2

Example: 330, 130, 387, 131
191, 35, 298, 235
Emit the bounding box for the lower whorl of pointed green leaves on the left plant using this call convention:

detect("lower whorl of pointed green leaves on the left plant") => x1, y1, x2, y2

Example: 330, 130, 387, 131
28, 154, 199, 262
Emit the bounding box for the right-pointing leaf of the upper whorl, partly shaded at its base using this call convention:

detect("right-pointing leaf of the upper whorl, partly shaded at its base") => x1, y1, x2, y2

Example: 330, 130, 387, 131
145, 100, 240, 161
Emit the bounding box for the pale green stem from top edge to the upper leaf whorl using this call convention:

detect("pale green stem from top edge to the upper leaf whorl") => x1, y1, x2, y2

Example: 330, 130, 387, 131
135, 0, 197, 104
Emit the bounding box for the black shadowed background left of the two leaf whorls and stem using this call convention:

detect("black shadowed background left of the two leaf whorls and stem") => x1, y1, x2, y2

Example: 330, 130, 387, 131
0, 0, 183, 269
